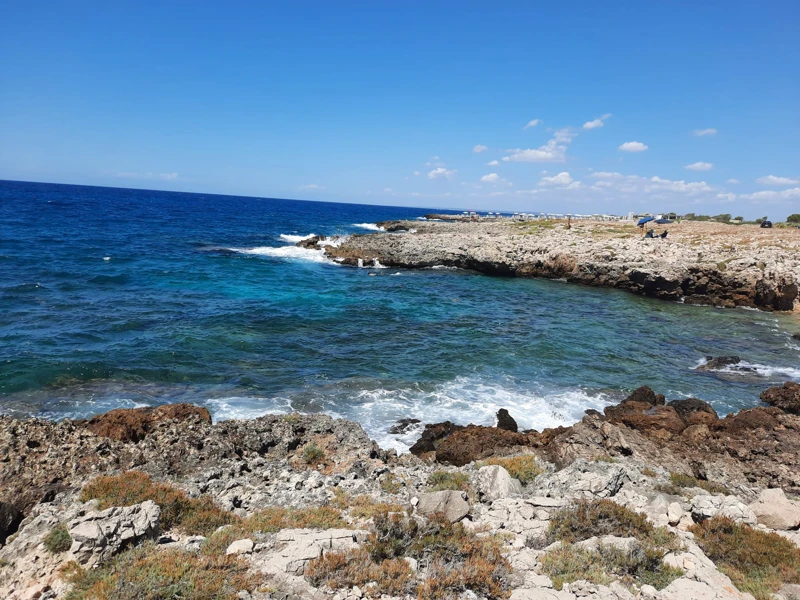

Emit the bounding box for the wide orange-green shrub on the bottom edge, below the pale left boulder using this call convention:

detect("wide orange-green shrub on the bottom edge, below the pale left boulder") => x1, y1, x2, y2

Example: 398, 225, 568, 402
63, 544, 262, 600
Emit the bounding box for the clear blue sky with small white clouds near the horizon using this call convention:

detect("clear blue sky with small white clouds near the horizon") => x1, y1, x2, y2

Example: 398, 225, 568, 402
0, 0, 800, 220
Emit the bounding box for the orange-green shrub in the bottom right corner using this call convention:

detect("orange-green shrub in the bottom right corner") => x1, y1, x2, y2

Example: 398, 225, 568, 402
690, 517, 800, 600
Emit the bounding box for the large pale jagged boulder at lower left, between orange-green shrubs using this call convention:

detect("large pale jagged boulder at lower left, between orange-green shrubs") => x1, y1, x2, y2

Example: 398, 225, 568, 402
67, 500, 161, 564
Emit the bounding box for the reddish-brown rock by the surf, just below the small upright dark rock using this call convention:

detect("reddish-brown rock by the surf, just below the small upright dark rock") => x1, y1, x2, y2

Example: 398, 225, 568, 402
436, 425, 537, 467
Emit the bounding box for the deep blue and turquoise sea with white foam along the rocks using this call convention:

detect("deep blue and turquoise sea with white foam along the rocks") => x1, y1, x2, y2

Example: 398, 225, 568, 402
0, 181, 800, 449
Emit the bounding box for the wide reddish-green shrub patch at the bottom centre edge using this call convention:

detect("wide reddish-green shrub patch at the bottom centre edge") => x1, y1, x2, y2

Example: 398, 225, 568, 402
306, 514, 511, 600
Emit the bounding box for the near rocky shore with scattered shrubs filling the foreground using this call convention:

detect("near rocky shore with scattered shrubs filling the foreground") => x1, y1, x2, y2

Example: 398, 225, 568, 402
0, 383, 800, 600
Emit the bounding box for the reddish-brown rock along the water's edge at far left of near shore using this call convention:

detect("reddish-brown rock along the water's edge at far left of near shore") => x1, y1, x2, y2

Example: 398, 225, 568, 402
76, 404, 211, 442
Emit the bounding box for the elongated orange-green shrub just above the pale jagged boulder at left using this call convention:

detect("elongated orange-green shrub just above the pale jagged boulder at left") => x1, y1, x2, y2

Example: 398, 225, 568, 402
80, 471, 238, 535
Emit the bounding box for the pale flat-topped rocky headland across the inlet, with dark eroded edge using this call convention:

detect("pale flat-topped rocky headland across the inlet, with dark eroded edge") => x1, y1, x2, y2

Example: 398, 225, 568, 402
308, 221, 800, 311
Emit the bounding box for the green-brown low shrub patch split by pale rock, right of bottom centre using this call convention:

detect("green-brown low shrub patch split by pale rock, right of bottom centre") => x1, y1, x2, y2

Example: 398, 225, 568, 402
542, 500, 682, 589
